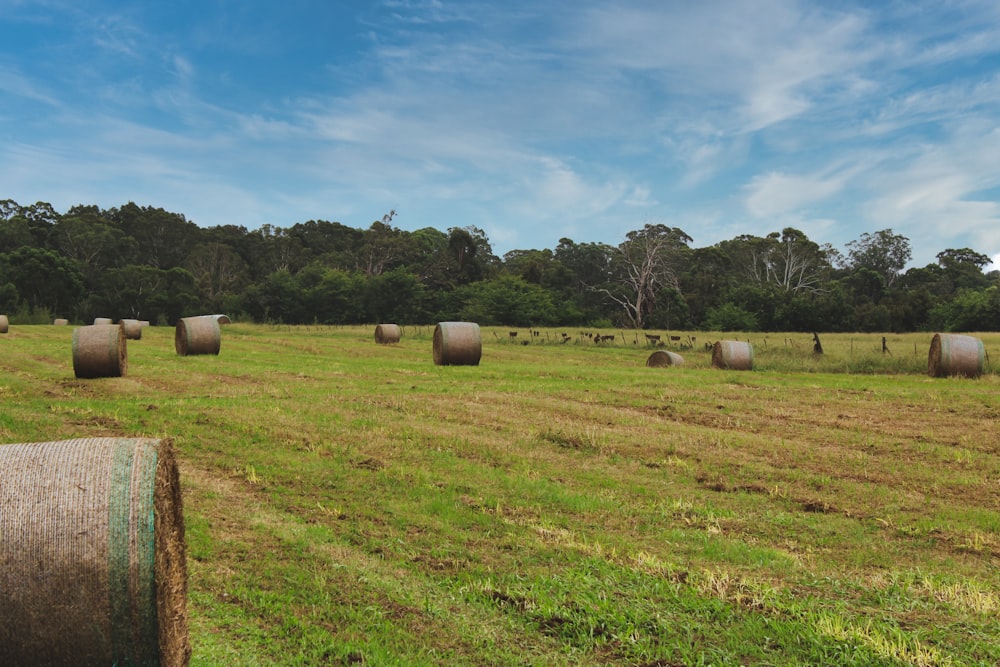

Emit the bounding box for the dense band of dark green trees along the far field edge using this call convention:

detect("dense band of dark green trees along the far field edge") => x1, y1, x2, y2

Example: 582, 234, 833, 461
0, 199, 1000, 332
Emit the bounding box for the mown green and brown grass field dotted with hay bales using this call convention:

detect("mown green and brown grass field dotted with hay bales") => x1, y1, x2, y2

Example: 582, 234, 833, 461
0, 324, 1000, 666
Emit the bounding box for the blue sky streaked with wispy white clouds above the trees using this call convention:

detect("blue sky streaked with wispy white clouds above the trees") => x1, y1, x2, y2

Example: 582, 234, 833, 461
0, 0, 1000, 266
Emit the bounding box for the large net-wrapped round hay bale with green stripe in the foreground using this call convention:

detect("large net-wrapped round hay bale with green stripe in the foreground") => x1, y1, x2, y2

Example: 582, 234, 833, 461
0, 438, 191, 667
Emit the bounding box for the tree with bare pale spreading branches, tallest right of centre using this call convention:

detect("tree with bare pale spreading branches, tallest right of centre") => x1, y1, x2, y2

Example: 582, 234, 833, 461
594, 224, 691, 329
